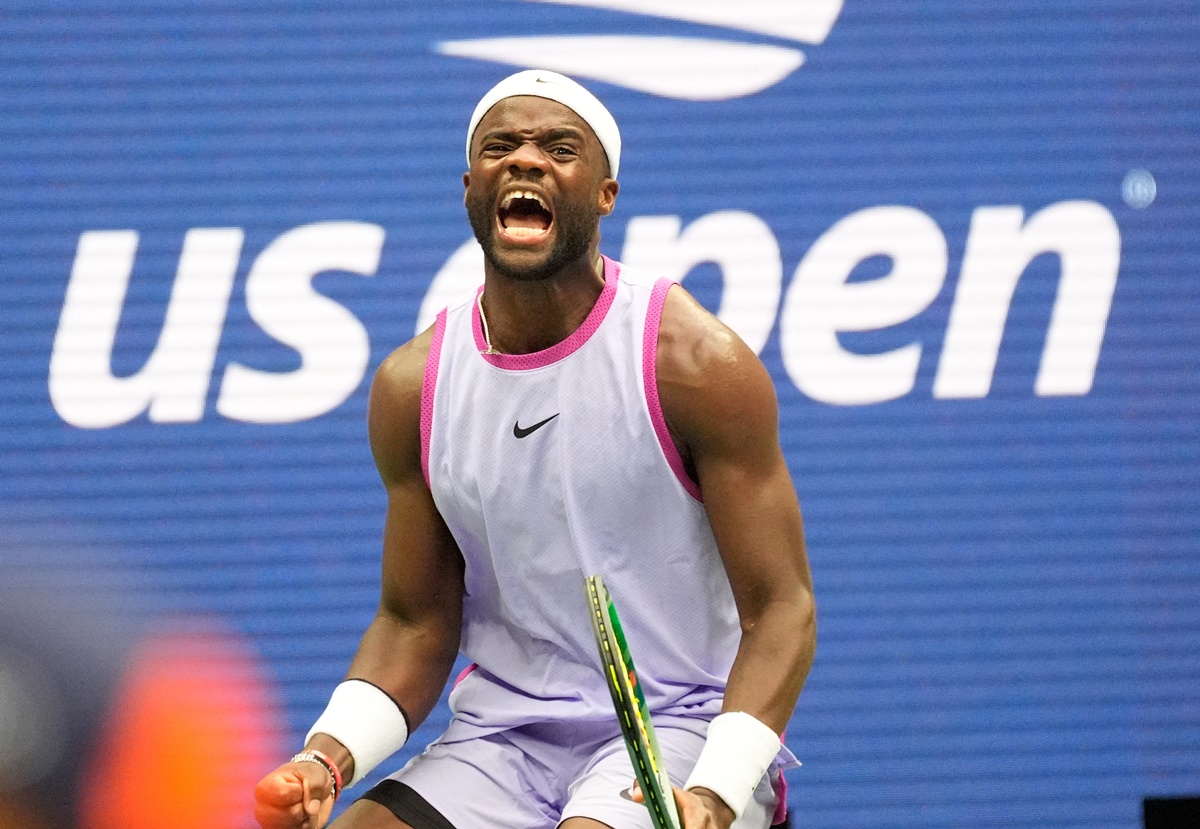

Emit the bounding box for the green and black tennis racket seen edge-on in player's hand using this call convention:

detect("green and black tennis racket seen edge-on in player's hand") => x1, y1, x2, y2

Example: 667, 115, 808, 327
583, 575, 679, 829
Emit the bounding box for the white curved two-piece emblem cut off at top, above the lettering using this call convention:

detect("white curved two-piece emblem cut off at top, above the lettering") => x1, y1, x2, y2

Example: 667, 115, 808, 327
437, 0, 842, 101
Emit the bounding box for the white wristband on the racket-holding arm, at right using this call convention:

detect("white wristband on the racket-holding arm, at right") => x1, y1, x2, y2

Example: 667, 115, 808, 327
683, 711, 780, 817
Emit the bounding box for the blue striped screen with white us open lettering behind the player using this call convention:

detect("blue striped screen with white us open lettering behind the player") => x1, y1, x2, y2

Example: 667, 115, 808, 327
0, 0, 1200, 829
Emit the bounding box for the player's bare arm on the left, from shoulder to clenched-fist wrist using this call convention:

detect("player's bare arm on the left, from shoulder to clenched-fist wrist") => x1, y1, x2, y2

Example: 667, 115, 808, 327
311, 323, 463, 780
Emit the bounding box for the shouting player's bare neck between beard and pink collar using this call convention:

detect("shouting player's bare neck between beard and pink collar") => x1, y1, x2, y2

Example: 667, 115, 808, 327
480, 250, 604, 354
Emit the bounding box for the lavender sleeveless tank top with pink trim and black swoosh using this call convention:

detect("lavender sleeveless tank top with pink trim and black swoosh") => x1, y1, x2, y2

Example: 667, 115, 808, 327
421, 258, 740, 740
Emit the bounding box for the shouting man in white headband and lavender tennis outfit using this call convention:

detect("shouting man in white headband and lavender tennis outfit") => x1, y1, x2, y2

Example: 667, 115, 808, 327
256, 71, 815, 829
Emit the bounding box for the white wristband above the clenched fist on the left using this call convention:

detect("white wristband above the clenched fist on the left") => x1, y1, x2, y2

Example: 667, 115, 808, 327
305, 679, 408, 788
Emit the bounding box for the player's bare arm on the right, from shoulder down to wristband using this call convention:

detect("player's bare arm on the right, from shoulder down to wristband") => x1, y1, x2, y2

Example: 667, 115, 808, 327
656, 288, 816, 732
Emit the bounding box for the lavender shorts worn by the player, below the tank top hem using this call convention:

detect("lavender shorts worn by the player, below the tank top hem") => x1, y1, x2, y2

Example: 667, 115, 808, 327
379, 717, 780, 829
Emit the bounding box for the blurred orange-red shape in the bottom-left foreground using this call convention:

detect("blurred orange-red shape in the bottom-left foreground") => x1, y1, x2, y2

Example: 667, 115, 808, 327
80, 631, 283, 829
